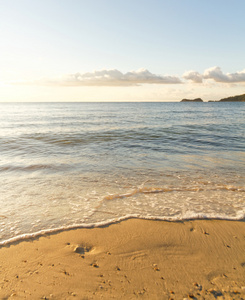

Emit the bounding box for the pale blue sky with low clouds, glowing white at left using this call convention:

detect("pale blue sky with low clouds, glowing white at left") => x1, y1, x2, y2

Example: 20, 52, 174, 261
0, 0, 245, 102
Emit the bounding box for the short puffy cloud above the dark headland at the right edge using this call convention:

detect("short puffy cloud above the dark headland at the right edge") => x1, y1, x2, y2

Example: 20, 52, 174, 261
182, 67, 245, 83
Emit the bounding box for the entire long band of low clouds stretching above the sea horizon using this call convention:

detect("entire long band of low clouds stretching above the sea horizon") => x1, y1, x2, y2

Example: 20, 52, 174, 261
7, 66, 245, 86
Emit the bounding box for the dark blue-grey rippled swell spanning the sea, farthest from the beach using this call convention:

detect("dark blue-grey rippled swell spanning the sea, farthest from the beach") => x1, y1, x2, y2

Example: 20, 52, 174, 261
0, 126, 244, 151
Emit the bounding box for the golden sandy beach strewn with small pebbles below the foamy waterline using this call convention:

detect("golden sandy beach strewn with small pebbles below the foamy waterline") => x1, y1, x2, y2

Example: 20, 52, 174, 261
0, 219, 245, 299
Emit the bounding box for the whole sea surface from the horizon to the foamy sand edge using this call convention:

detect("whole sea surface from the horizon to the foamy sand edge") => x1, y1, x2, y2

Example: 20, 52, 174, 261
0, 103, 245, 243
